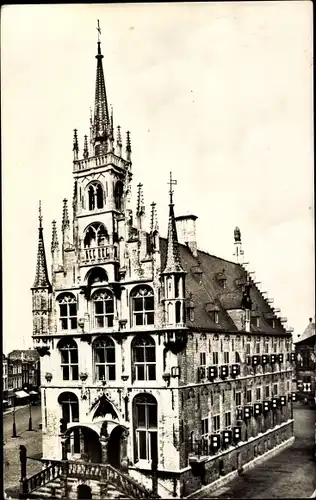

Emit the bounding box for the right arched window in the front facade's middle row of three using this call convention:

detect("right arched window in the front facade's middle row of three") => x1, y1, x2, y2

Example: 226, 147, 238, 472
132, 336, 156, 380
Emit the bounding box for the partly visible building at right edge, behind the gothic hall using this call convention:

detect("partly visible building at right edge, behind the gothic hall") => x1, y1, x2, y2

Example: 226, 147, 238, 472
295, 318, 316, 403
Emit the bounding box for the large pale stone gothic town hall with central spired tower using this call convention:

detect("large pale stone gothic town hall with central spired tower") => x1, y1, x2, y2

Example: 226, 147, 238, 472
32, 32, 294, 498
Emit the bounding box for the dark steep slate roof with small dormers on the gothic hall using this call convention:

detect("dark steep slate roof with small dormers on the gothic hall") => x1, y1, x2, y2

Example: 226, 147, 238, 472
160, 238, 289, 335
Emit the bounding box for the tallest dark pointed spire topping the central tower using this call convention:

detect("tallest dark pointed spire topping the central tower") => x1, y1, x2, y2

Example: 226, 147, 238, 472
93, 20, 110, 146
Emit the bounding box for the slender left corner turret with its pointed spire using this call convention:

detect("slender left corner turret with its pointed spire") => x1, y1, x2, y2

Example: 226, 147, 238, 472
31, 202, 52, 335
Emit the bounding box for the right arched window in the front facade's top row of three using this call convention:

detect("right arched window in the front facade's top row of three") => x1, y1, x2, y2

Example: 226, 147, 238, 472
131, 286, 155, 326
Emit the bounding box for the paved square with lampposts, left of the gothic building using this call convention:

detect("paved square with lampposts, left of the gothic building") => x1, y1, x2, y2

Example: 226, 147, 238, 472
3, 405, 42, 498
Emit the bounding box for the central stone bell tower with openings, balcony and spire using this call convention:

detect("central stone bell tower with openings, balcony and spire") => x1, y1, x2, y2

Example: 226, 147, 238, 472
73, 33, 132, 285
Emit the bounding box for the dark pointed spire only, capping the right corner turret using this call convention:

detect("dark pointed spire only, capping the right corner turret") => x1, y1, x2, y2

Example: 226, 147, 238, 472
163, 172, 184, 274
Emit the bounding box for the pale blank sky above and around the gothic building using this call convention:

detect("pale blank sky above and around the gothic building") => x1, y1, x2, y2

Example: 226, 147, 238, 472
1, 1, 315, 353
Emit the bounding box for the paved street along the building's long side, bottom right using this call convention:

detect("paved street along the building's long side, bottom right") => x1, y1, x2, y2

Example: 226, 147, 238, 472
196, 407, 316, 499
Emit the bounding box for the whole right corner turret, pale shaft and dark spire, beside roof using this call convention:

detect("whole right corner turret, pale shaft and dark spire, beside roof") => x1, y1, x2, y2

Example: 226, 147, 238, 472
162, 172, 186, 327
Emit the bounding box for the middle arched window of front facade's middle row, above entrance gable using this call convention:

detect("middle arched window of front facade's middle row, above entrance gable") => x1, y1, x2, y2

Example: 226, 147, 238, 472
93, 338, 115, 380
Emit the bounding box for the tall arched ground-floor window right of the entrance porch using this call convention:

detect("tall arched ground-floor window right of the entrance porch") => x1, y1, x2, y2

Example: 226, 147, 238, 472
133, 394, 158, 462
